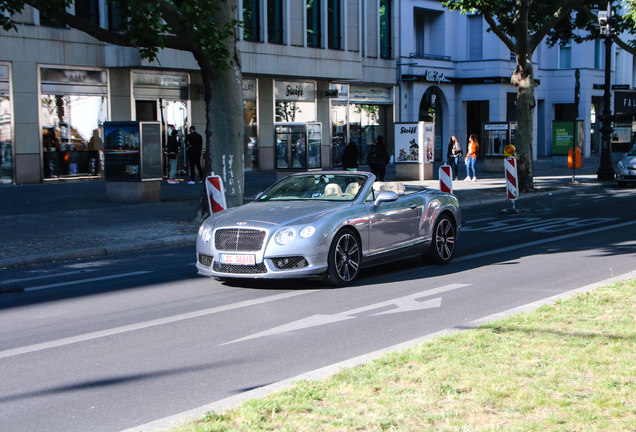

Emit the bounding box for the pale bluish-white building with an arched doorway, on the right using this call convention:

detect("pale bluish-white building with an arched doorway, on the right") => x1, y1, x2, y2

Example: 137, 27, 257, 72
396, 0, 636, 170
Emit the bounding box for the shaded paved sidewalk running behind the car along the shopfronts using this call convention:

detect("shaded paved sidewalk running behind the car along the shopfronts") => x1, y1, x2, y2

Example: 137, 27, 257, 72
0, 158, 614, 272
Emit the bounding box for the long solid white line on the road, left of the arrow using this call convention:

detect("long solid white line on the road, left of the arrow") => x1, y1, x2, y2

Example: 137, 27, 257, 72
0, 290, 319, 359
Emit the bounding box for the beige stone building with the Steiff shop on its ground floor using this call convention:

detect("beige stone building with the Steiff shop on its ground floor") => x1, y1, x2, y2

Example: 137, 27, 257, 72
0, 0, 399, 184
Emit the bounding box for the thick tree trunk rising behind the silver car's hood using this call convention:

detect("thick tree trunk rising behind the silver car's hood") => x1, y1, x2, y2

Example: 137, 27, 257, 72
195, 1, 245, 222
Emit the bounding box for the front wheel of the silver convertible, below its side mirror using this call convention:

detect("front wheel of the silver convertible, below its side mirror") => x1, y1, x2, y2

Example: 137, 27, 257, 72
325, 228, 362, 287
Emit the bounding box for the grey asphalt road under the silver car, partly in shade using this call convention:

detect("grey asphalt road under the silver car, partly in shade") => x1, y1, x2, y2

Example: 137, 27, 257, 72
0, 188, 636, 432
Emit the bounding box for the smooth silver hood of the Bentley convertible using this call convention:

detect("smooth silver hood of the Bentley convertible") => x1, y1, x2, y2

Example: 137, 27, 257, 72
213, 201, 351, 228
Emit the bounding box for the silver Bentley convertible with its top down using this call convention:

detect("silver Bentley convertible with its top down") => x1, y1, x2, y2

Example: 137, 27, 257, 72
197, 171, 461, 286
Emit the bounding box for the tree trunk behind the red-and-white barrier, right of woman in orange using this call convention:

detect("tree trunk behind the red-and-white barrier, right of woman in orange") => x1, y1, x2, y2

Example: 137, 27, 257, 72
511, 61, 536, 193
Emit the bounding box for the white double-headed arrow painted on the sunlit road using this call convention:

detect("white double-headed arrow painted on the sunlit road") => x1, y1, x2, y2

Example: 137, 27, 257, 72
221, 284, 469, 345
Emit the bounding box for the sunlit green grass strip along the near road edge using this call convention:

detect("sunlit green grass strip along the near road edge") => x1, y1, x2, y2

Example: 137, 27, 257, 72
174, 279, 636, 432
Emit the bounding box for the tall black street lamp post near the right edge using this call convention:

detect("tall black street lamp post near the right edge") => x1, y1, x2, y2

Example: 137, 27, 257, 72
596, 0, 614, 181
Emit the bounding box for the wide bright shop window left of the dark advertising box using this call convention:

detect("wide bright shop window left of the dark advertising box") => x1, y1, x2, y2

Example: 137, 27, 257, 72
41, 95, 107, 178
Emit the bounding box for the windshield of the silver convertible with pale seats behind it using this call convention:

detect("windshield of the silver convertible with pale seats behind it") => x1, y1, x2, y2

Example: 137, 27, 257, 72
257, 173, 367, 201
